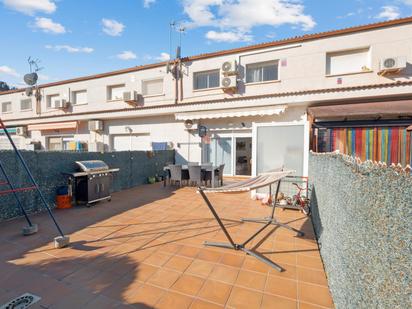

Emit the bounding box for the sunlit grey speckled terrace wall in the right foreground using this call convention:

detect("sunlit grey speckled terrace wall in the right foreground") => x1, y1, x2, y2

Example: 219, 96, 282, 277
309, 153, 412, 309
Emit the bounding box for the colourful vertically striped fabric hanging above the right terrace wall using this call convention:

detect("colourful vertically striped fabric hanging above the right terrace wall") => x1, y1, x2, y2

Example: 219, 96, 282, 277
317, 127, 412, 166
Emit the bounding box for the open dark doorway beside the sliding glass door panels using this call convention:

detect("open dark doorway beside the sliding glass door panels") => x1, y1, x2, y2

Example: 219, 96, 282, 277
234, 137, 252, 176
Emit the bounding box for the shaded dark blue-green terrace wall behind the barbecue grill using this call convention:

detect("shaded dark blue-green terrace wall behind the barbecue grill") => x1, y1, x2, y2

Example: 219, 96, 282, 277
0, 150, 174, 221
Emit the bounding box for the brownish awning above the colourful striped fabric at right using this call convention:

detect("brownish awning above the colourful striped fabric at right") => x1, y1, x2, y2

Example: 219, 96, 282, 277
308, 100, 412, 119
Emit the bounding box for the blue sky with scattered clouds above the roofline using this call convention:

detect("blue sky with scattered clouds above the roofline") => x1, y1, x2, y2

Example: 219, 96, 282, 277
0, 0, 412, 87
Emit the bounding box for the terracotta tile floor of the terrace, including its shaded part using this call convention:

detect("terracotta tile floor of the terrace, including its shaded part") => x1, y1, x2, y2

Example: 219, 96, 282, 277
0, 184, 333, 309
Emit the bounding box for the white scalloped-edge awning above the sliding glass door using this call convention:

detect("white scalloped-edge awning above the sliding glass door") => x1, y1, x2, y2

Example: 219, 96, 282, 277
175, 105, 286, 120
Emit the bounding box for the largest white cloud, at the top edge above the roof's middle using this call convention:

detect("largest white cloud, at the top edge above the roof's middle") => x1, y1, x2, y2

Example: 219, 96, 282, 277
183, 0, 316, 42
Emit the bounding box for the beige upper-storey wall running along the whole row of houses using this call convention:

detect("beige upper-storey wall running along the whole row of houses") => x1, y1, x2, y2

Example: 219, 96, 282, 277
0, 25, 412, 123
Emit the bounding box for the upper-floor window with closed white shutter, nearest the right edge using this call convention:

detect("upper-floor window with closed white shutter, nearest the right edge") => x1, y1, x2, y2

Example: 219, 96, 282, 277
326, 48, 370, 75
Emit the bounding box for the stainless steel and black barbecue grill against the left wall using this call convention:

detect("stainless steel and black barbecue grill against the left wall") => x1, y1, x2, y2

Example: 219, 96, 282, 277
66, 160, 119, 206
